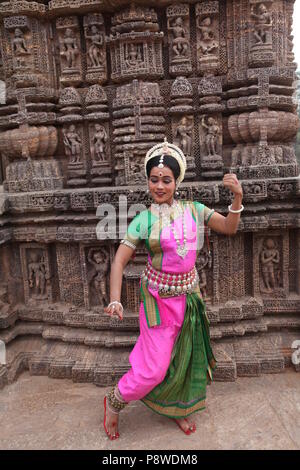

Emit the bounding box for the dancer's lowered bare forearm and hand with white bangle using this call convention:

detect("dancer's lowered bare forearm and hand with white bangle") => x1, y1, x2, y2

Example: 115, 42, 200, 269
104, 244, 135, 320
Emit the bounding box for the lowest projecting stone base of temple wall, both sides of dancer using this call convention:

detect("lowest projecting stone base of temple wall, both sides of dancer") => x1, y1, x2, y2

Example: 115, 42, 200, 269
0, 332, 299, 388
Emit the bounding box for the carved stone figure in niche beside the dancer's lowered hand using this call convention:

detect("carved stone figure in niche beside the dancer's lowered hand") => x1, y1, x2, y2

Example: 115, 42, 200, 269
88, 248, 109, 307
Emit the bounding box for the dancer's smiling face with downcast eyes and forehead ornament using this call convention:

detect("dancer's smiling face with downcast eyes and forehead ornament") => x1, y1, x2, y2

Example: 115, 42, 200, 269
148, 165, 176, 204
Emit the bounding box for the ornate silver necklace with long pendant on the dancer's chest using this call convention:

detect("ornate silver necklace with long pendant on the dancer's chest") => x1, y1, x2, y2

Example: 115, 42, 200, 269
152, 201, 188, 258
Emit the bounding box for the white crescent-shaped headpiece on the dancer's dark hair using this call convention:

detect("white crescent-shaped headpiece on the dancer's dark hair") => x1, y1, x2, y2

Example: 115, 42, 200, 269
145, 137, 186, 187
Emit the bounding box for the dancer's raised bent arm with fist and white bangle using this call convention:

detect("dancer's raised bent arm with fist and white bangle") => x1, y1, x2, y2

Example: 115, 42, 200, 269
207, 173, 243, 235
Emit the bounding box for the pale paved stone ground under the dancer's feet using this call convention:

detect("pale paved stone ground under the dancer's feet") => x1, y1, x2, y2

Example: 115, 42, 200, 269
0, 370, 300, 450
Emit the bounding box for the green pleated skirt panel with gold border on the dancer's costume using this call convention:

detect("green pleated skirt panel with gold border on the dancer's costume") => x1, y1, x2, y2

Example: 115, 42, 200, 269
142, 293, 217, 418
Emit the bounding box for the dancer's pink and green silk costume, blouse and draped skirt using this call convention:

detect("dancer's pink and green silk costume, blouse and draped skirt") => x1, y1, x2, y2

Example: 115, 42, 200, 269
118, 201, 217, 418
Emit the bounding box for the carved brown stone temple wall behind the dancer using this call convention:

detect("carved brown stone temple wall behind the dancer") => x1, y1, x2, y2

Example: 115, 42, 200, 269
0, 0, 300, 386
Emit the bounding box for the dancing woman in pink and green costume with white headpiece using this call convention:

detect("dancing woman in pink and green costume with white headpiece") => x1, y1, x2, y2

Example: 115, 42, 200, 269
104, 141, 244, 439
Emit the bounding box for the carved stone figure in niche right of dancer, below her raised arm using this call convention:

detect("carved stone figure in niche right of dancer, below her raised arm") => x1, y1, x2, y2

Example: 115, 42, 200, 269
260, 238, 280, 292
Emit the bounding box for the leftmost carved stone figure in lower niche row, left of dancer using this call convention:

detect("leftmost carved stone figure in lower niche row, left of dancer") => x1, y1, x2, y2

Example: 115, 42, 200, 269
28, 251, 49, 299
